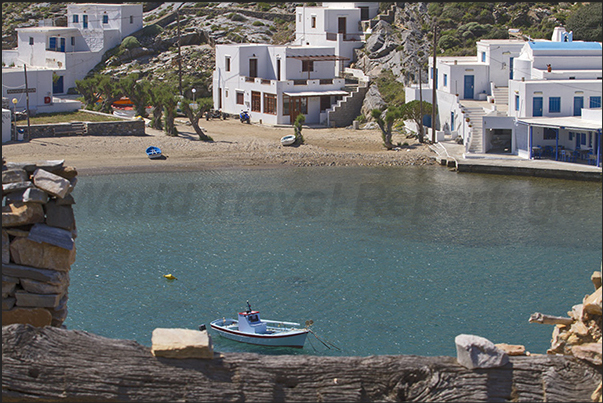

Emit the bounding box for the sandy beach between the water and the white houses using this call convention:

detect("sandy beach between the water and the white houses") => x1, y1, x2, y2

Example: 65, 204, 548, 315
2, 118, 435, 175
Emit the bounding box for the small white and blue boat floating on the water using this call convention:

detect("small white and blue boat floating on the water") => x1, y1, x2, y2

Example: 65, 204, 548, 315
210, 302, 310, 348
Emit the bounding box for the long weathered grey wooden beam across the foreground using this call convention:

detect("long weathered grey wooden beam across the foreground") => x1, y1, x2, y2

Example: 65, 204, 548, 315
2, 325, 601, 402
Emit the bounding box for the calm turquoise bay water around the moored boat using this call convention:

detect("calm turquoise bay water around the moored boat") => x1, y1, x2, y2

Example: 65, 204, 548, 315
65, 167, 602, 356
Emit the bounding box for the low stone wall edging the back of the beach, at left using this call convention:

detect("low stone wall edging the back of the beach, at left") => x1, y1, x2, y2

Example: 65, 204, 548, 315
17, 120, 145, 139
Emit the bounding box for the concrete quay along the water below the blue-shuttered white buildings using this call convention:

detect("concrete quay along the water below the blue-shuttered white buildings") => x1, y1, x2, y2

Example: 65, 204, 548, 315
430, 140, 602, 182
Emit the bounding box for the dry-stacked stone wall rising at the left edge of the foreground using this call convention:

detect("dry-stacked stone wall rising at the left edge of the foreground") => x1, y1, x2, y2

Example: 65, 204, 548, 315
2, 158, 77, 327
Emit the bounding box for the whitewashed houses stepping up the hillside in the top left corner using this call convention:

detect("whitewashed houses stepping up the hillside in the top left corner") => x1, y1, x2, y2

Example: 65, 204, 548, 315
2, 3, 143, 112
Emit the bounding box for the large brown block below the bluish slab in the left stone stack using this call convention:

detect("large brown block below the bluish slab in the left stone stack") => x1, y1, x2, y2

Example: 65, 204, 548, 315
10, 237, 75, 271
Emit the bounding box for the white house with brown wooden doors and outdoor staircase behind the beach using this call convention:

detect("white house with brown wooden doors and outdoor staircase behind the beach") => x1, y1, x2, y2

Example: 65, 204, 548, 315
213, 3, 378, 126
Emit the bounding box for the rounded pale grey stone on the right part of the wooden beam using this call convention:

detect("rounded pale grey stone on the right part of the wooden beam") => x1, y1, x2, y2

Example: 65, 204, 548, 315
454, 334, 509, 369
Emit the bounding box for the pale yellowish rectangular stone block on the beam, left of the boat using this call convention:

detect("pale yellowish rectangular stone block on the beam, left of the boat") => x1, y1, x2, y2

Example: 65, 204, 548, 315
151, 328, 214, 359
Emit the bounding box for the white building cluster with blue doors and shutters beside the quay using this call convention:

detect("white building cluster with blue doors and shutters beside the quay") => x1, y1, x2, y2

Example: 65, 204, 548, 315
406, 27, 602, 167
